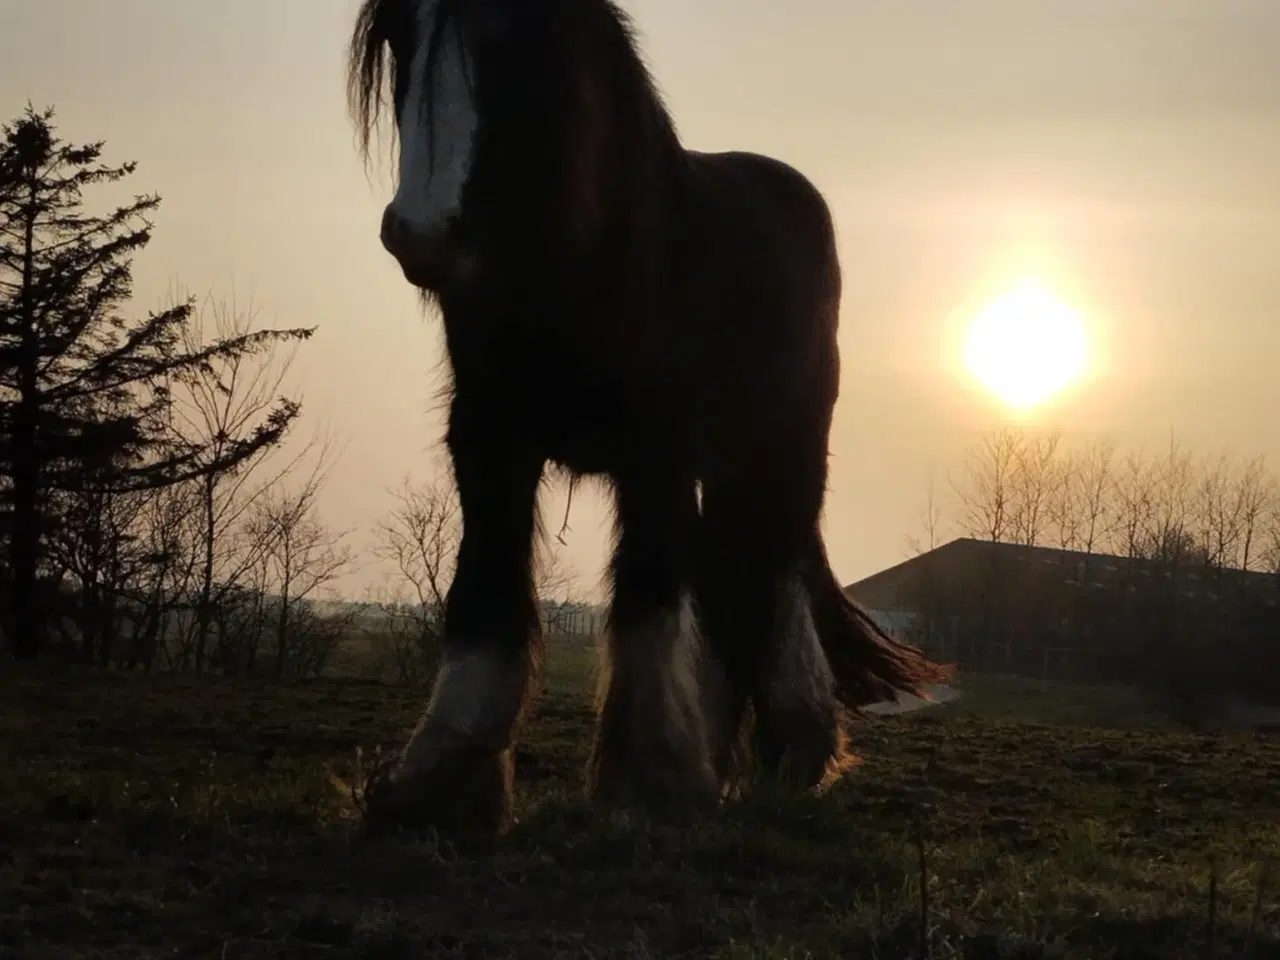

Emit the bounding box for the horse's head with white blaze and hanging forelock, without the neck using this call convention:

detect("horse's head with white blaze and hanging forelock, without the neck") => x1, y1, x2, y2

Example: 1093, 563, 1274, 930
348, 0, 539, 291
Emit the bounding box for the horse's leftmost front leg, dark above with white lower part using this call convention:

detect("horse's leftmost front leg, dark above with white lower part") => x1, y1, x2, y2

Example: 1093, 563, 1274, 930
369, 402, 543, 832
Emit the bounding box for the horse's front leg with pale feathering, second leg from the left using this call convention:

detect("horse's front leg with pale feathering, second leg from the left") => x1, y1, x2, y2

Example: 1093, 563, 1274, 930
591, 470, 719, 806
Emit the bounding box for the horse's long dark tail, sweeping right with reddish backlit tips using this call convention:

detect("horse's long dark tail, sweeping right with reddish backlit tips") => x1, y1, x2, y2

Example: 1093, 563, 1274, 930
805, 531, 955, 710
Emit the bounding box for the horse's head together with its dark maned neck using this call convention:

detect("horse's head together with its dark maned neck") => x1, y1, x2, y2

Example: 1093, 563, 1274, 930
348, 0, 680, 293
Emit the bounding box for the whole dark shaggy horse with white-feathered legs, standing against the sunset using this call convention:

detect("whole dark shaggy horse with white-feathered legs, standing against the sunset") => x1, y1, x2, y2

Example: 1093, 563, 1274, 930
348, 0, 950, 829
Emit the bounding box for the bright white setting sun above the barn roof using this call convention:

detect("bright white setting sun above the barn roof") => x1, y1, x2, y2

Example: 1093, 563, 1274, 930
964, 283, 1088, 410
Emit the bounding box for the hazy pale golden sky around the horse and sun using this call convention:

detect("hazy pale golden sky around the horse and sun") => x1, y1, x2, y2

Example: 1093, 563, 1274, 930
0, 0, 1280, 601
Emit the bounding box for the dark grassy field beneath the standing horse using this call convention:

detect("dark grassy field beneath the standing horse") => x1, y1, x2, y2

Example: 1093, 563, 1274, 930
0, 650, 1280, 960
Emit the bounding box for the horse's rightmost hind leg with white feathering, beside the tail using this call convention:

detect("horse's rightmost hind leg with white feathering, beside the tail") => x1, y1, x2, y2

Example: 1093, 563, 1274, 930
701, 451, 842, 788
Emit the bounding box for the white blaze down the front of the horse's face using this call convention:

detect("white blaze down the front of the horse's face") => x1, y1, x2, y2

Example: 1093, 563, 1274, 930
392, 0, 477, 233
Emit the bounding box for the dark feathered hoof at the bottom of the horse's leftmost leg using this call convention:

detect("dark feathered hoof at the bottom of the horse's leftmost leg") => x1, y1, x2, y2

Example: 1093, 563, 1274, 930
364, 748, 515, 837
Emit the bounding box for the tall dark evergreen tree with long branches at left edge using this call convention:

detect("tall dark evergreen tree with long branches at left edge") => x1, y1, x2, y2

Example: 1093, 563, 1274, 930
0, 105, 312, 659
